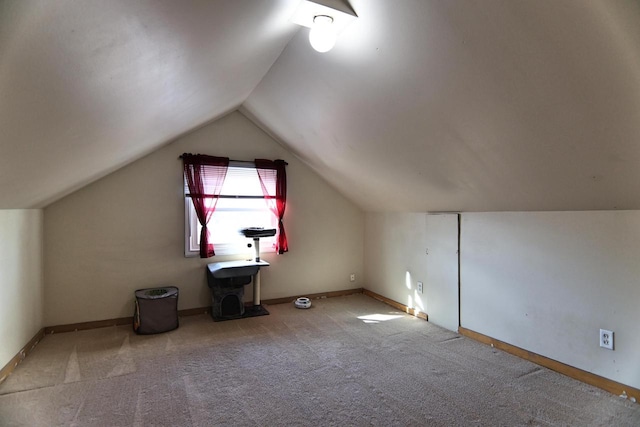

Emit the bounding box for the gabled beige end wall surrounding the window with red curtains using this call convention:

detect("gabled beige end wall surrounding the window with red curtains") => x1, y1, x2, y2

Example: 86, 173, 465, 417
44, 112, 364, 326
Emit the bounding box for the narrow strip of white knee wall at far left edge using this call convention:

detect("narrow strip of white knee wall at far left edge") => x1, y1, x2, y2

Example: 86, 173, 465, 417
0, 209, 44, 368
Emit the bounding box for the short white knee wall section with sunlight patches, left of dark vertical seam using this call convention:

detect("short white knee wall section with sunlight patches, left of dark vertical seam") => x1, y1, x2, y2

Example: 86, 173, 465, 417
365, 212, 458, 331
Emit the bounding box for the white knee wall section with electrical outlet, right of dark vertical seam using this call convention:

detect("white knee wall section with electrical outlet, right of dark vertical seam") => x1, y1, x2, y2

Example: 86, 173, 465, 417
461, 211, 640, 387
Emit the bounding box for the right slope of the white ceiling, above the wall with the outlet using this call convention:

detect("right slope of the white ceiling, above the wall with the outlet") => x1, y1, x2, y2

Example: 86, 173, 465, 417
243, 0, 640, 211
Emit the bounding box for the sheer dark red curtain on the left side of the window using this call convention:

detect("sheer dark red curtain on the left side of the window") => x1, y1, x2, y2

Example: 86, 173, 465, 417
182, 153, 229, 258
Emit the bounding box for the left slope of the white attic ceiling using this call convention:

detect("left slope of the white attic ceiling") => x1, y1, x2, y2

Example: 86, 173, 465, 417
0, 0, 298, 208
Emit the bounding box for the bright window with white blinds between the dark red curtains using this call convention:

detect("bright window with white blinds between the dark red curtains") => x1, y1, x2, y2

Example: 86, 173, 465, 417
184, 161, 278, 257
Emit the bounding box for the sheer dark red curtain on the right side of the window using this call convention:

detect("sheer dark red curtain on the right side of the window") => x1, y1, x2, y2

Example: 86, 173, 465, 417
255, 159, 289, 254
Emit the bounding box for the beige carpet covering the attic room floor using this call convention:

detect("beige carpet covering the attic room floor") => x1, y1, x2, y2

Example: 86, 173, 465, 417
0, 295, 640, 426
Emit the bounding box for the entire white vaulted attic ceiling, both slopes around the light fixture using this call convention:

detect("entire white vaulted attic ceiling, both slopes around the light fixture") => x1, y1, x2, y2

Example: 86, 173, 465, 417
0, 0, 640, 211
